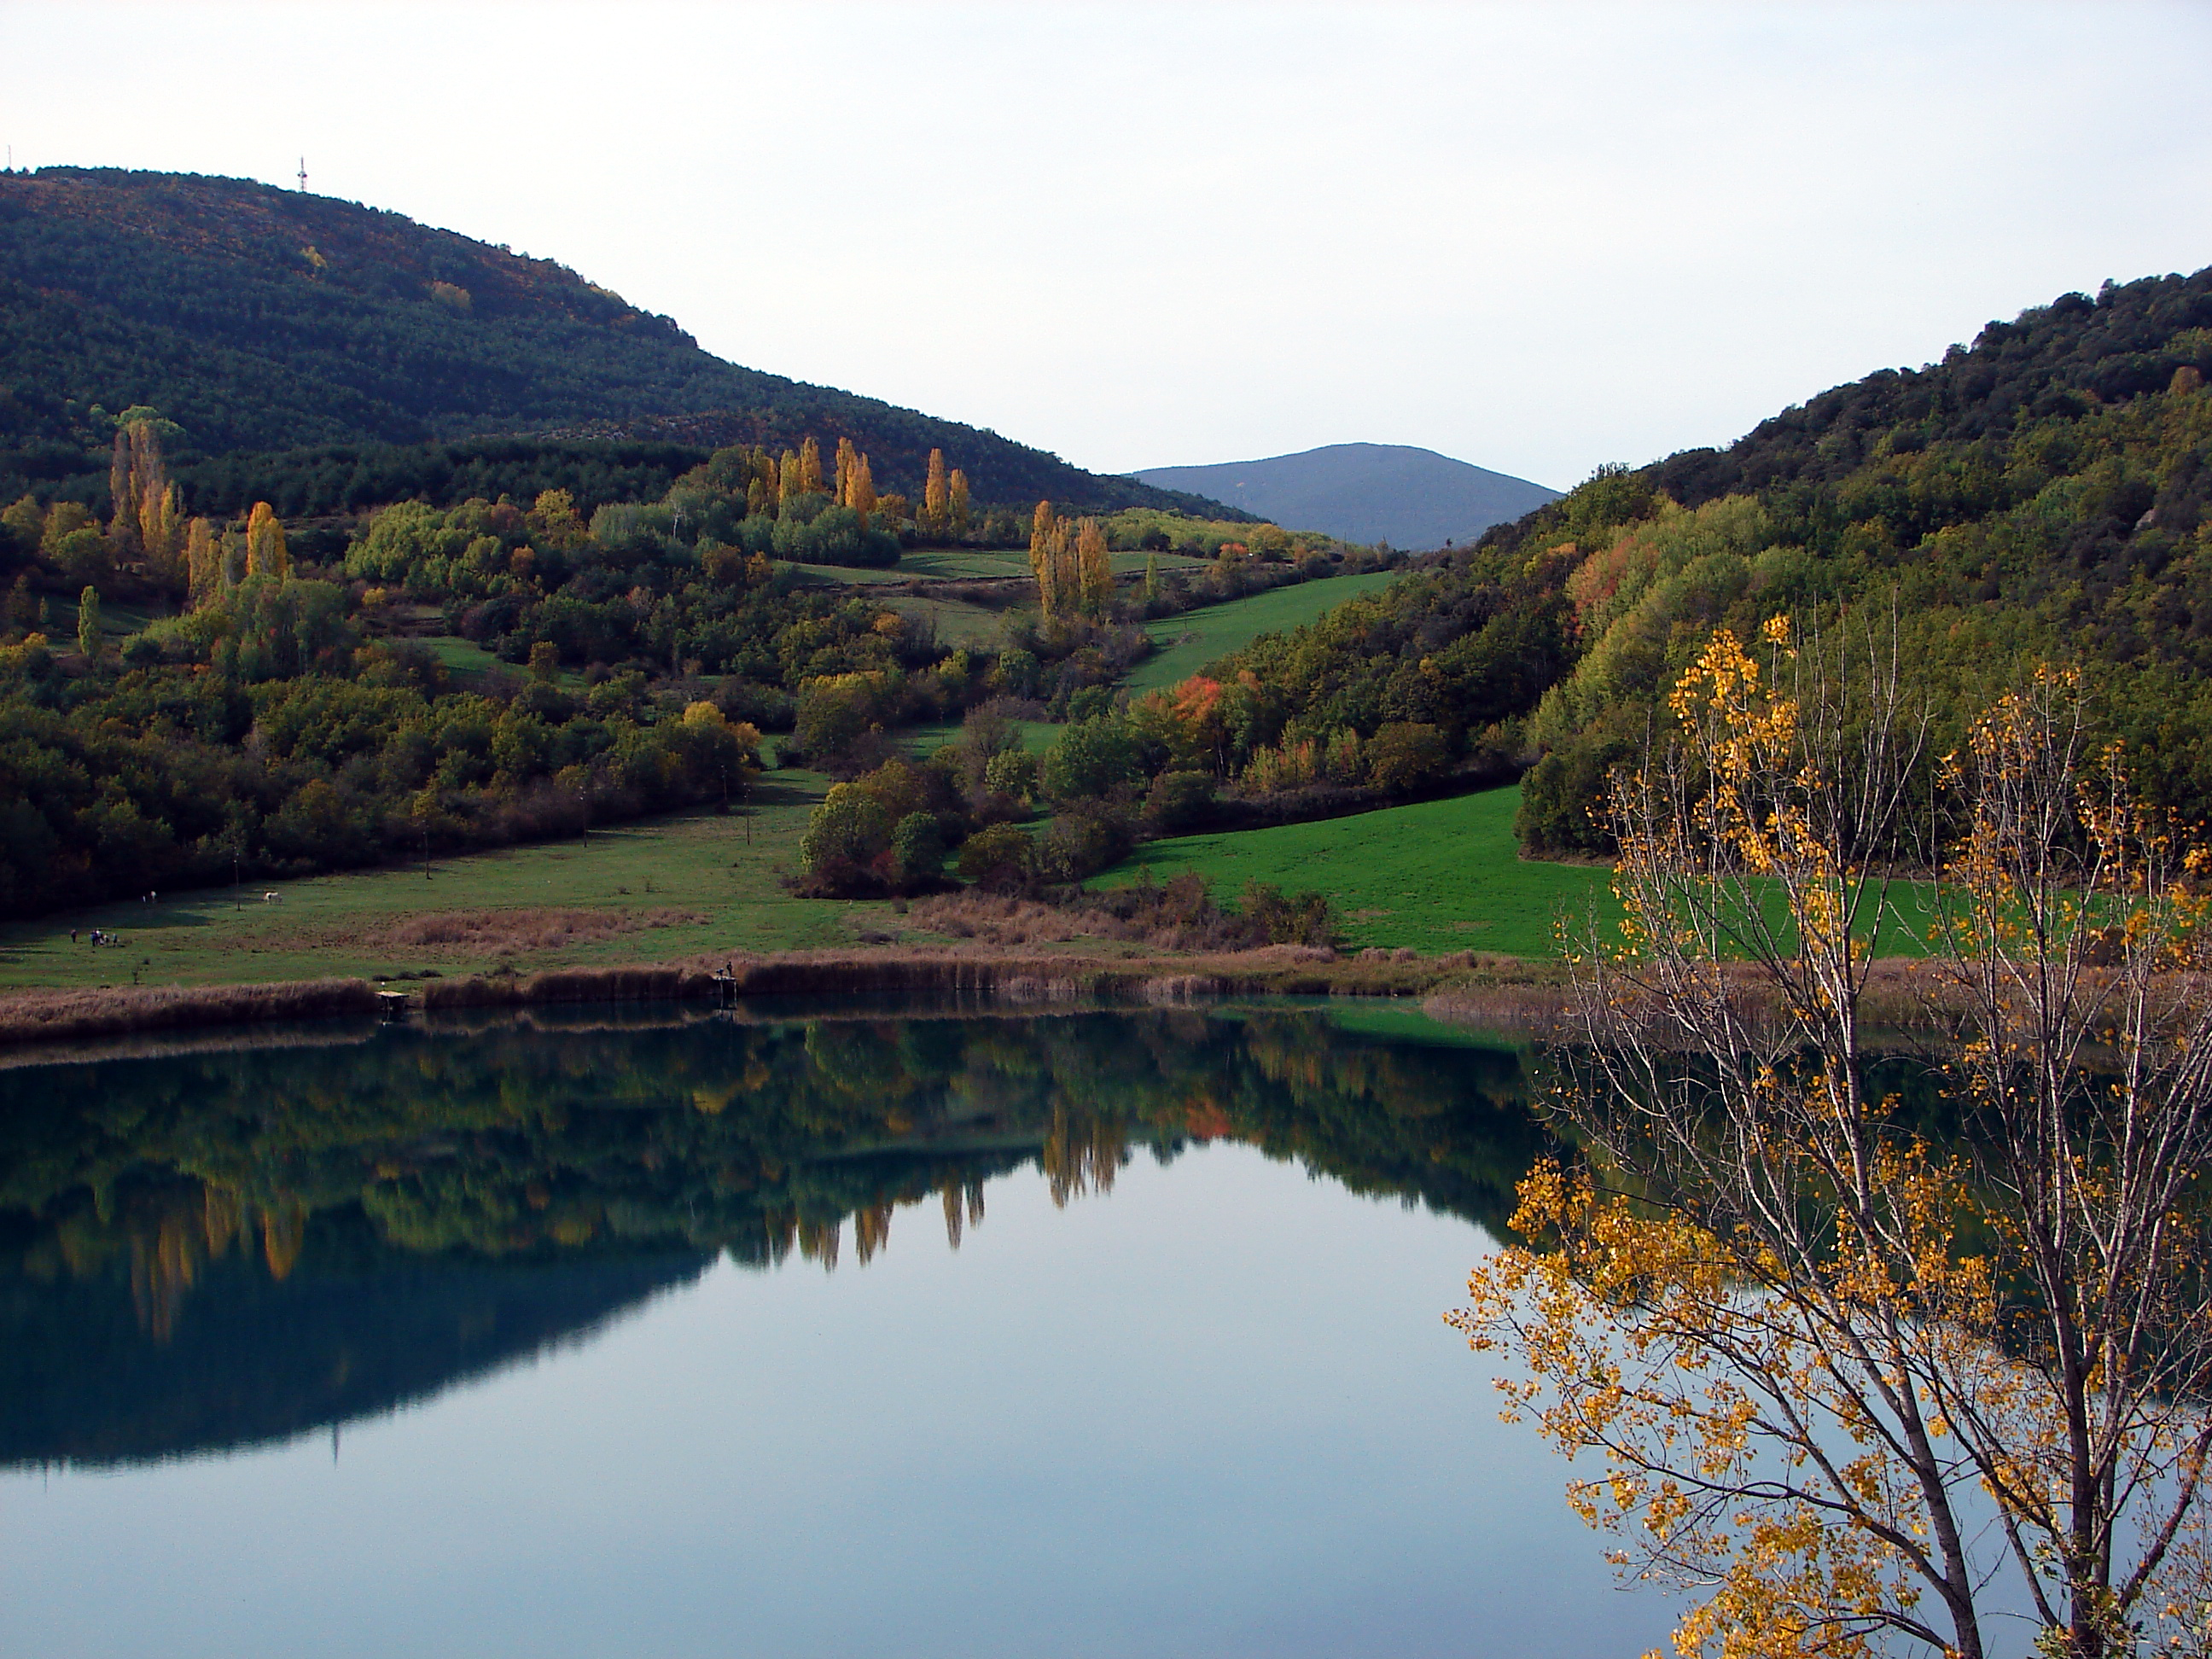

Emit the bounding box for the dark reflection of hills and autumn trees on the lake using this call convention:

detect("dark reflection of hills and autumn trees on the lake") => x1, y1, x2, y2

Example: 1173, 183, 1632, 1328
0, 1009, 1537, 1466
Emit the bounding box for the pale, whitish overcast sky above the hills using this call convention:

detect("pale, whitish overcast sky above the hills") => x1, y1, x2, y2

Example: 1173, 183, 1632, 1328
0, 0, 2212, 486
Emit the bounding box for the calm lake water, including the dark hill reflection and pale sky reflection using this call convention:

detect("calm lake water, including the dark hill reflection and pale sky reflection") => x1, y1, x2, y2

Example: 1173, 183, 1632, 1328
0, 1006, 1673, 1659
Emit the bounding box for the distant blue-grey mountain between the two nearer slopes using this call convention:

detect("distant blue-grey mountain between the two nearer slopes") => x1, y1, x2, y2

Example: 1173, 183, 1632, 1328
1132, 445, 1559, 549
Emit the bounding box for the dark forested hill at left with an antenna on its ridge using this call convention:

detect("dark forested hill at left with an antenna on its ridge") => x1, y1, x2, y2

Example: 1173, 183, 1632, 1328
0, 168, 1217, 515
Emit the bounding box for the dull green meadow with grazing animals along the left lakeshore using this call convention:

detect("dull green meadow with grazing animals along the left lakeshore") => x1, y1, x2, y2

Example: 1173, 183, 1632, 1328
0, 770, 916, 989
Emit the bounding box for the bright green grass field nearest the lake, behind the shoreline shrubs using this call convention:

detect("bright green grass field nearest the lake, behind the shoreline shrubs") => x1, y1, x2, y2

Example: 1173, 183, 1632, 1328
1102, 785, 1606, 956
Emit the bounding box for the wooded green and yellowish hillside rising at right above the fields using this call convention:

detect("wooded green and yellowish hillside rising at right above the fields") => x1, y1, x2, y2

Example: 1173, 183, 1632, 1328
1194, 270, 2212, 849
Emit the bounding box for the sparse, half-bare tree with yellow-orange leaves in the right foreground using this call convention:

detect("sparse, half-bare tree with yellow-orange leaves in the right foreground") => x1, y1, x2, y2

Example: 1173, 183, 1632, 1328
1451, 620, 2212, 1659
